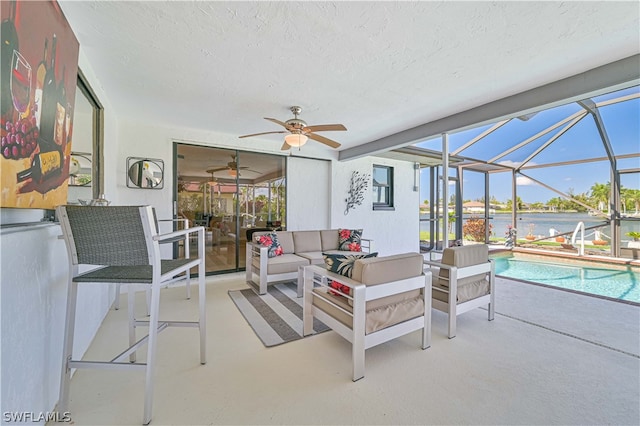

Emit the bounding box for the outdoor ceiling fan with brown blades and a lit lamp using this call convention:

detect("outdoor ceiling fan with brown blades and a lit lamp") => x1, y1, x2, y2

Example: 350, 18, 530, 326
240, 106, 347, 151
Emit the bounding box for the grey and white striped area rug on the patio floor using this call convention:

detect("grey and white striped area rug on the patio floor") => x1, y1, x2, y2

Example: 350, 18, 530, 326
229, 281, 329, 347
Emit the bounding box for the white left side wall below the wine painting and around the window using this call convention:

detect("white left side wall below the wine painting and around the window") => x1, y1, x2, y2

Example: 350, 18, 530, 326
0, 50, 117, 420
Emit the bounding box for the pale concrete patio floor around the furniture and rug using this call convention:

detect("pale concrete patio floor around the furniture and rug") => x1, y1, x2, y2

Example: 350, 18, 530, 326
58, 273, 640, 425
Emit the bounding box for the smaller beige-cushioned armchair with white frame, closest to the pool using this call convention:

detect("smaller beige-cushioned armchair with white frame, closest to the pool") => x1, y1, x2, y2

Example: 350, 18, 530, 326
424, 244, 495, 339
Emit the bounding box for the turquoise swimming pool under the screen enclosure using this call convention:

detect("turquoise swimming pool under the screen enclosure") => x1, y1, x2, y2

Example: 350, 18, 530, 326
491, 253, 640, 303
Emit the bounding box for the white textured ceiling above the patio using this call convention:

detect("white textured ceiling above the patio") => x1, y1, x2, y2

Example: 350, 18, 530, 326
59, 0, 640, 154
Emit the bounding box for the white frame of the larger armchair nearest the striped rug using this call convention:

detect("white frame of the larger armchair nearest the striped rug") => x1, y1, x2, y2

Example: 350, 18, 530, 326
301, 265, 431, 382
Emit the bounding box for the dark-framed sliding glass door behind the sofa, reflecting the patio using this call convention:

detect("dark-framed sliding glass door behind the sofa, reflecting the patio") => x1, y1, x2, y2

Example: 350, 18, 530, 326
174, 143, 286, 273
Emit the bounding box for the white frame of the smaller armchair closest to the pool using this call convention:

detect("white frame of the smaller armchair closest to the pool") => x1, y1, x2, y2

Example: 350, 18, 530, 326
424, 255, 496, 339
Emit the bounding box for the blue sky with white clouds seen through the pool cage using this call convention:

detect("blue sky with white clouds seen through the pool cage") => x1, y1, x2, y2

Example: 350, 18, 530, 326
416, 86, 640, 203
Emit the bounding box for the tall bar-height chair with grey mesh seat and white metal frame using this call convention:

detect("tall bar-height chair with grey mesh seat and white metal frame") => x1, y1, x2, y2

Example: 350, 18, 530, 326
56, 206, 206, 424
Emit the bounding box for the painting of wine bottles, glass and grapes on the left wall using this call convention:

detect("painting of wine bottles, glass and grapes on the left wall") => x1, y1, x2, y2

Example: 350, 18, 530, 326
0, 0, 80, 209
